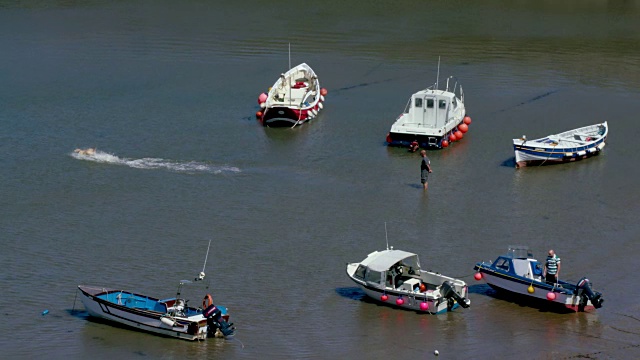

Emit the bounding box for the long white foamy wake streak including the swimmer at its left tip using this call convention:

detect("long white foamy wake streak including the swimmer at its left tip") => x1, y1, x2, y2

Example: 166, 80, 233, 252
71, 150, 241, 174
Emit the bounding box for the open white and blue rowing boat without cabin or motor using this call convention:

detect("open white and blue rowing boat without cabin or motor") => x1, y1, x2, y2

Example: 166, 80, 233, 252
513, 121, 609, 167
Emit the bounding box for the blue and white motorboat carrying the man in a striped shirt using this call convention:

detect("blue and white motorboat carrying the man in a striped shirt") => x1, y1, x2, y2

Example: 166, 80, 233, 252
474, 246, 604, 311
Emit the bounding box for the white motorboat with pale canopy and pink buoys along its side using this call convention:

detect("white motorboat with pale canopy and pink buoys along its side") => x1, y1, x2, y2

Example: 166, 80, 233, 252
347, 247, 471, 314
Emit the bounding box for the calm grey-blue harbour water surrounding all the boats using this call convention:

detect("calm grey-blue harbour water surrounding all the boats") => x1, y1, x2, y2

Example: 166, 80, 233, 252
0, 1, 640, 359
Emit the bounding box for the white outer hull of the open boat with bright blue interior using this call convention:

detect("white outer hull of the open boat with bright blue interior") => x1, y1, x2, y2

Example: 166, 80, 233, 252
79, 286, 208, 340
